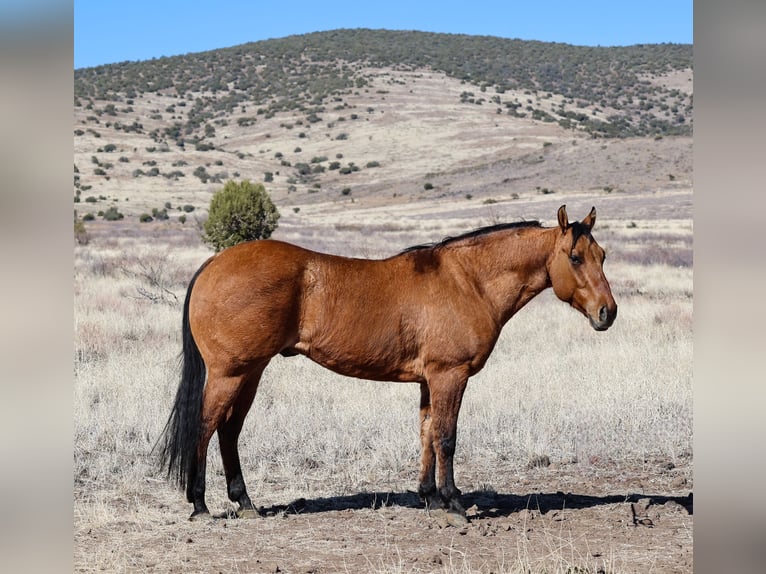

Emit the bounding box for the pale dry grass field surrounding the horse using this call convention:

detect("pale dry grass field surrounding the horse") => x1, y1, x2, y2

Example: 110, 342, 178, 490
74, 214, 692, 572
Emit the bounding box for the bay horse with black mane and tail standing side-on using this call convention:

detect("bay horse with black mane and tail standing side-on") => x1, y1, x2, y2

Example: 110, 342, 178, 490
155, 205, 617, 519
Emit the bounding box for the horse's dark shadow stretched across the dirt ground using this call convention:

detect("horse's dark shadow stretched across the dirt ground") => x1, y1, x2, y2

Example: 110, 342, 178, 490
258, 491, 694, 519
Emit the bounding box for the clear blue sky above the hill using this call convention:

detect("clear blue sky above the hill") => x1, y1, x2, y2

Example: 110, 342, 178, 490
74, 0, 693, 68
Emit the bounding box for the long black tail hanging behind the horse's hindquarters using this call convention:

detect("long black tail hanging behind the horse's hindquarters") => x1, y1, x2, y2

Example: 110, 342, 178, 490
154, 260, 209, 489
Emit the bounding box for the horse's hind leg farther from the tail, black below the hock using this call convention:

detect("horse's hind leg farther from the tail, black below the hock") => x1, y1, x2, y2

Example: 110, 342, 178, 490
218, 364, 266, 517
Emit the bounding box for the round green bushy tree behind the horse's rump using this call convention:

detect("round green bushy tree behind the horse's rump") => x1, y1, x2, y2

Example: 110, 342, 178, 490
202, 180, 279, 252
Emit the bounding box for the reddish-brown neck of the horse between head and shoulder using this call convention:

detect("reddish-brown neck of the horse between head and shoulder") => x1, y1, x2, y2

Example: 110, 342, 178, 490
452, 228, 555, 324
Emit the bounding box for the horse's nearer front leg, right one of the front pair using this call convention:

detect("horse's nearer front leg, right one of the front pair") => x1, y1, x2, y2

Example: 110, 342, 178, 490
421, 371, 468, 516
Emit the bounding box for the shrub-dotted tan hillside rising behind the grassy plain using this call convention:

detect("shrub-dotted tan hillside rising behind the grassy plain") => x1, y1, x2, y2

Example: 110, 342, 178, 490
74, 30, 693, 226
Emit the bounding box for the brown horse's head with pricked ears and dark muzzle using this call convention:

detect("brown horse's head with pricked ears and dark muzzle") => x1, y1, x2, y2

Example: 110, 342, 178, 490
548, 205, 617, 331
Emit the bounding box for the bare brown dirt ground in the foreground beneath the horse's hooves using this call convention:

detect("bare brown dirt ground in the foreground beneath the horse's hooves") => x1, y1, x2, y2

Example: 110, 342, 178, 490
75, 460, 693, 574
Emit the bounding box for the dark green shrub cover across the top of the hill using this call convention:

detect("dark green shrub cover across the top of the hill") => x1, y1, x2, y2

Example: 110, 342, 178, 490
74, 29, 693, 141
